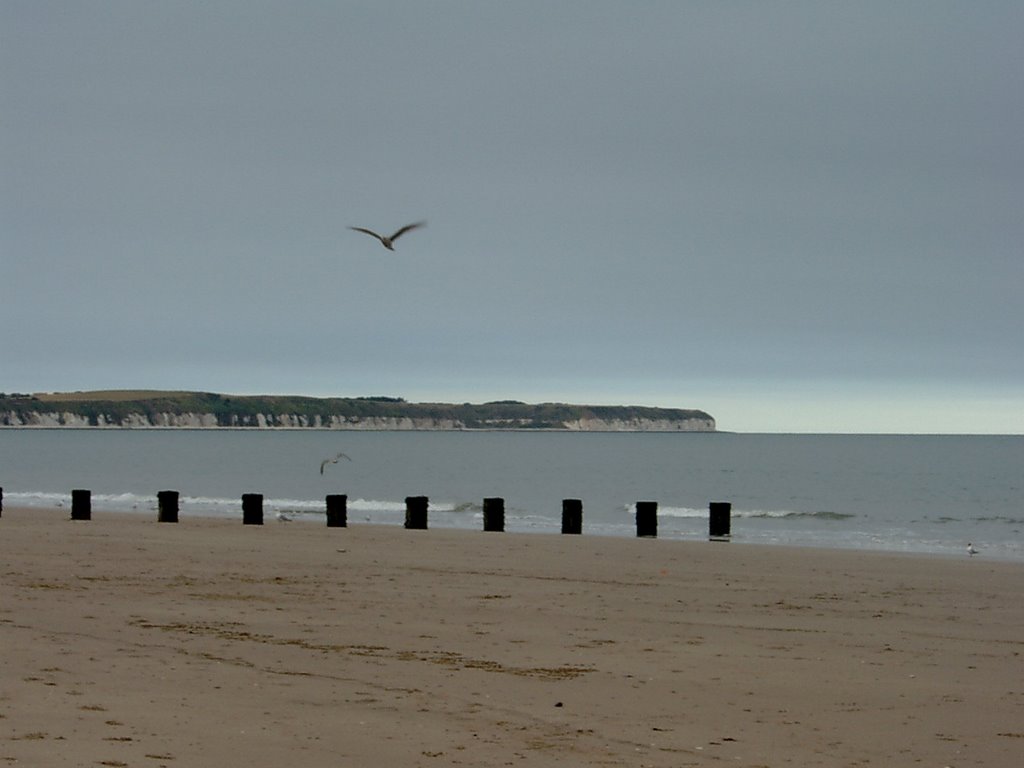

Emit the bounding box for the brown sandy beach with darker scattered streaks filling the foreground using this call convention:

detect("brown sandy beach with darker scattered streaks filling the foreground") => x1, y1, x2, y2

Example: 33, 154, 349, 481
0, 509, 1024, 768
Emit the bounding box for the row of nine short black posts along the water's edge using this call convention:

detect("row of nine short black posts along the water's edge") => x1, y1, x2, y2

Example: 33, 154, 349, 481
8, 488, 732, 541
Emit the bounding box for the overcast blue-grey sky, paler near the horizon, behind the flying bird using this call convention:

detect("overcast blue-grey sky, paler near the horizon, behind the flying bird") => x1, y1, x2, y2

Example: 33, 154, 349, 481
0, 0, 1024, 433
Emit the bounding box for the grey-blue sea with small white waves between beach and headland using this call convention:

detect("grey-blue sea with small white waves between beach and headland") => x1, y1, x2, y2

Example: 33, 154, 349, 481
0, 429, 1024, 560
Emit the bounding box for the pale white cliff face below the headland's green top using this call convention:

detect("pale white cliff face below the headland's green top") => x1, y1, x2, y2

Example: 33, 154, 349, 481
0, 411, 715, 432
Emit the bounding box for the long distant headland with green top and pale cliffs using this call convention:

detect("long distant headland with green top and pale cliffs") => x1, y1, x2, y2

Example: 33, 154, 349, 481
0, 390, 716, 432
